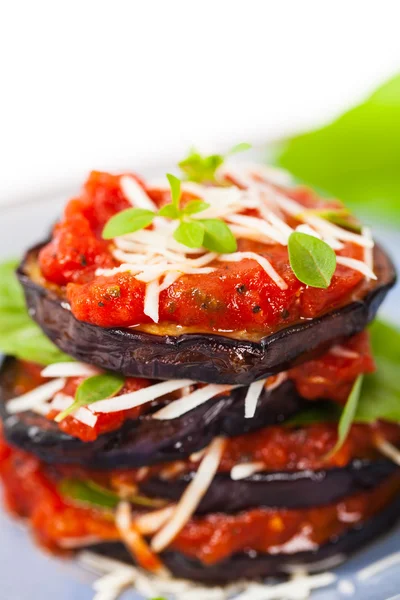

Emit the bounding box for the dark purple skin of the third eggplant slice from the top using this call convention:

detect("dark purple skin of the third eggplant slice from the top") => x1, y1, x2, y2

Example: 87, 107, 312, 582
139, 459, 400, 514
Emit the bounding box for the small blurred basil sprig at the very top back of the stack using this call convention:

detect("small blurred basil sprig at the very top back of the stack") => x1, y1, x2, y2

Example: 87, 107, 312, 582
178, 142, 251, 183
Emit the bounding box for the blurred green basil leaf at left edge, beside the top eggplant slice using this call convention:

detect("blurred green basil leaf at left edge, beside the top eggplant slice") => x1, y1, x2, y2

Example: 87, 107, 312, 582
0, 260, 73, 365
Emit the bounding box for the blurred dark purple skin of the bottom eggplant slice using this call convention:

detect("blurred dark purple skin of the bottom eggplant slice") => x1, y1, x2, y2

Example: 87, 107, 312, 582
90, 497, 400, 584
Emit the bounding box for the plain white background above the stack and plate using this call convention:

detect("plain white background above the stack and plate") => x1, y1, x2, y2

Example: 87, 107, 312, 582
0, 0, 400, 203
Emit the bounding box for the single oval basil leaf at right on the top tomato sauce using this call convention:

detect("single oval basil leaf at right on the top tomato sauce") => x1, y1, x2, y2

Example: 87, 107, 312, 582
288, 231, 336, 288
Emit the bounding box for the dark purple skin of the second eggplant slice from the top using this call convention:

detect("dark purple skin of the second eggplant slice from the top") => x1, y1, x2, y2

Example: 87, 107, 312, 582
0, 358, 304, 469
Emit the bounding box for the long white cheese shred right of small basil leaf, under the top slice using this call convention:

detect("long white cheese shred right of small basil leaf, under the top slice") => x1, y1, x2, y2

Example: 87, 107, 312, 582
90, 379, 194, 413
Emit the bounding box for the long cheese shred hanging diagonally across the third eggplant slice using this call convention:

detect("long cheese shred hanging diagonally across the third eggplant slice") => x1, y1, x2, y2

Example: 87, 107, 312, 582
151, 437, 225, 552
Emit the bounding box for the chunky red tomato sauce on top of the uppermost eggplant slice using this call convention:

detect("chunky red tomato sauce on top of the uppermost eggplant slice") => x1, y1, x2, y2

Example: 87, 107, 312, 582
39, 172, 363, 332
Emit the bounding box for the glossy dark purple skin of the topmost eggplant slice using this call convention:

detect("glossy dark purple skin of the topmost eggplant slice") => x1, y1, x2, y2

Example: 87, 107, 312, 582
17, 244, 396, 385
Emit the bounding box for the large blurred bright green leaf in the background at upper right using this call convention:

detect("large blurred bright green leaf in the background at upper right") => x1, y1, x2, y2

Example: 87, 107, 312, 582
275, 75, 400, 225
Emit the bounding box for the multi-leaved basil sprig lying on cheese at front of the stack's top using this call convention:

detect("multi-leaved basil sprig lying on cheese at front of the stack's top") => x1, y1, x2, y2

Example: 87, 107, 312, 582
103, 174, 237, 253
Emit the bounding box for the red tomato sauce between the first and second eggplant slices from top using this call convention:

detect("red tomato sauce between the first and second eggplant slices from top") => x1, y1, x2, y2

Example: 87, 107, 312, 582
7, 332, 374, 442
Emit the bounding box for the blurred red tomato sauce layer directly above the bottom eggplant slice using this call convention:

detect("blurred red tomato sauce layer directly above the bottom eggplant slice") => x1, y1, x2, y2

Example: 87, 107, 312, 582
0, 432, 400, 564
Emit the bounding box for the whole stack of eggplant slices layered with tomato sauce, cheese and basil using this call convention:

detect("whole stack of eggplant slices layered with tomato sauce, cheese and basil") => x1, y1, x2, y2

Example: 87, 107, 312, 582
0, 159, 400, 582
